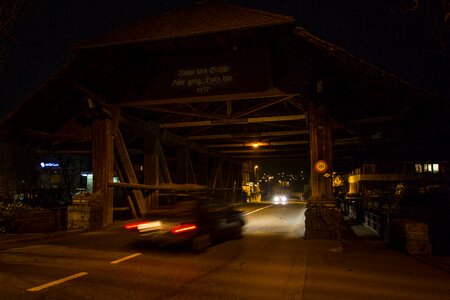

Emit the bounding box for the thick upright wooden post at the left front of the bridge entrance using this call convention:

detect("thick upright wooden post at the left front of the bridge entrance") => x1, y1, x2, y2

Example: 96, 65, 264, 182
92, 119, 114, 227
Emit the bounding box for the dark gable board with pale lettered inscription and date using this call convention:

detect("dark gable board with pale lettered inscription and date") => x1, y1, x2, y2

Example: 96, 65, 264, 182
146, 51, 270, 99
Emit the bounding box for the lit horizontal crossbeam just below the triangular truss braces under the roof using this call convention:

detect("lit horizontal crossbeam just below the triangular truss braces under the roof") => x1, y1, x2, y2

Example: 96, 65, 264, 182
159, 114, 306, 128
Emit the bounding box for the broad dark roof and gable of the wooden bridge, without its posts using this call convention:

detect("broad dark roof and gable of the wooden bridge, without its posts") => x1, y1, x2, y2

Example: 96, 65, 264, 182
0, 3, 450, 169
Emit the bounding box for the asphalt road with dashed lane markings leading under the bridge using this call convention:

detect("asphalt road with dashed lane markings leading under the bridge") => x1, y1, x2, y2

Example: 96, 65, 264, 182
0, 204, 450, 300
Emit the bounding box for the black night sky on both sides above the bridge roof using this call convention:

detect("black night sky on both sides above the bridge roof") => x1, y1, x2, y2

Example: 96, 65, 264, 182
0, 0, 450, 173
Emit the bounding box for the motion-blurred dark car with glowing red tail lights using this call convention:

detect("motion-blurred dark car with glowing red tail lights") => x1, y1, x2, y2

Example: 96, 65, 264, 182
125, 198, 245, 251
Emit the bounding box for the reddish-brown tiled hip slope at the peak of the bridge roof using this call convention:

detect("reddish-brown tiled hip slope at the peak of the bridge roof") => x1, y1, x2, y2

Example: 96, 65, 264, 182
76, 2, 295, 49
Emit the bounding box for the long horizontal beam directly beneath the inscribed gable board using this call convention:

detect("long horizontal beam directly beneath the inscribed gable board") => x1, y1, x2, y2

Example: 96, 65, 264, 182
119, 88, 287, 107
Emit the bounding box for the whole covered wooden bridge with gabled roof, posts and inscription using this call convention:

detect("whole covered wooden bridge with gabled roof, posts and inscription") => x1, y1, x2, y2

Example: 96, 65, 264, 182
0, 3, 444, 229
